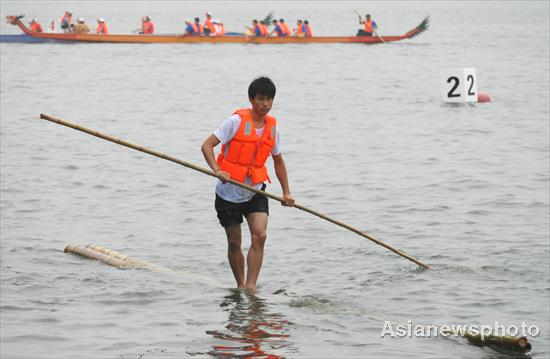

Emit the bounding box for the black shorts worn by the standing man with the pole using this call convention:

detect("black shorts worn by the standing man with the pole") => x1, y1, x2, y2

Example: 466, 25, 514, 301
214, 184, 269, 227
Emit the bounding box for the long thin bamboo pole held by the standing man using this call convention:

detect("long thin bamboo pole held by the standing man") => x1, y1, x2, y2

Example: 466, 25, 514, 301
40, 113, 430, 269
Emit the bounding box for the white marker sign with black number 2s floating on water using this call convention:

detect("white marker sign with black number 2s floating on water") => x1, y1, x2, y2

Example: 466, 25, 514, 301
441, 68, 477, 102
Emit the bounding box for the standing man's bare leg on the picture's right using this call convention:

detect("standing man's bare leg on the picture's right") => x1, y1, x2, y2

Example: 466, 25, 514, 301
245, 212, 267, 289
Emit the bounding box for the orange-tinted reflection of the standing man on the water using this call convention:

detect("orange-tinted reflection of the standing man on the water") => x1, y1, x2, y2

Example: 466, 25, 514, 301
206, 289, 292, 359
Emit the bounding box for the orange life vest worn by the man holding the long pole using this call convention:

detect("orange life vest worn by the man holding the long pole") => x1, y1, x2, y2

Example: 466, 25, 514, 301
217, 108, 277, 184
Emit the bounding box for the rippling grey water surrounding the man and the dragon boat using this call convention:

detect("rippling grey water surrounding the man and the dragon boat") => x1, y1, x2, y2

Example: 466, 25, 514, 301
0, 1, 550, 358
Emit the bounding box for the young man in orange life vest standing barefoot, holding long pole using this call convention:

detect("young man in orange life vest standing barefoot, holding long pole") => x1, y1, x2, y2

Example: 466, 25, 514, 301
201, 77, 294, 290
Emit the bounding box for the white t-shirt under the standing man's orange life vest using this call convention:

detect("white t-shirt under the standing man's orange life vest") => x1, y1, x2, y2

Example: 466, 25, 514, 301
214, 114, 281, 203
